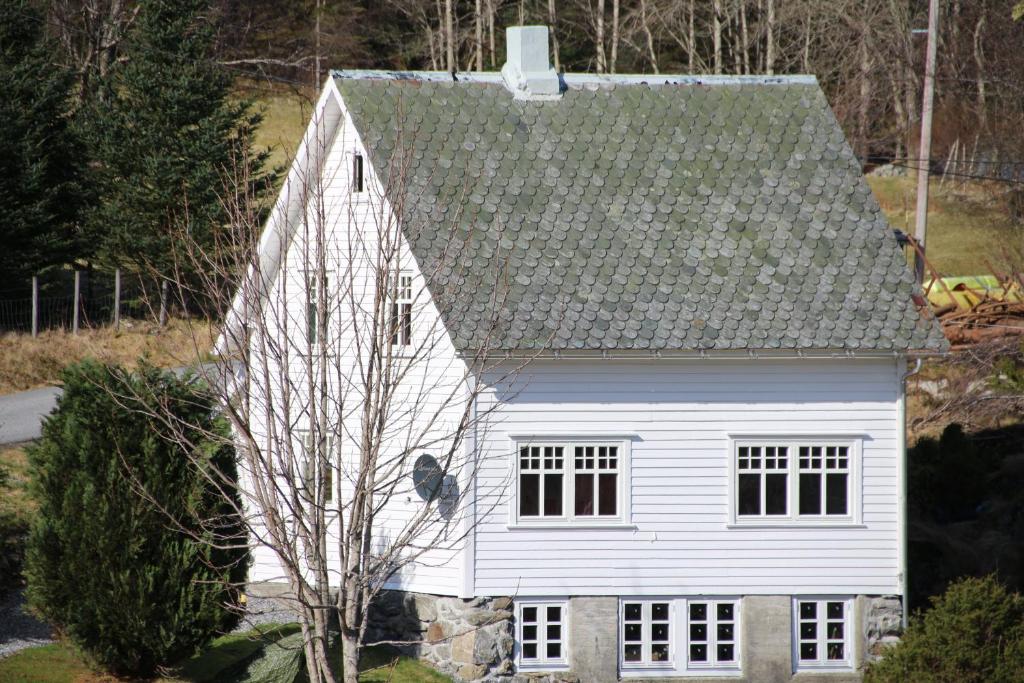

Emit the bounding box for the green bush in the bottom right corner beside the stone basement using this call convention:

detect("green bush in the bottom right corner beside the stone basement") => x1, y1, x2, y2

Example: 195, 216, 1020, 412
864, 577, 1024, 683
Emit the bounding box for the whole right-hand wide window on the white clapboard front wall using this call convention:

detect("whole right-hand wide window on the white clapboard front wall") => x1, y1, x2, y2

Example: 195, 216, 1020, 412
733, 439, 856, 523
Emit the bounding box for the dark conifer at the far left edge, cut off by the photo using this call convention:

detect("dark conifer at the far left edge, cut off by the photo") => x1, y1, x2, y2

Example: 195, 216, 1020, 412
0, 0, 87, 289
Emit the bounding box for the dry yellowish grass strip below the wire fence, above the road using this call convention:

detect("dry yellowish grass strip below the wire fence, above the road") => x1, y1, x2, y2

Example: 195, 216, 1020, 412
0, 321, 213, 394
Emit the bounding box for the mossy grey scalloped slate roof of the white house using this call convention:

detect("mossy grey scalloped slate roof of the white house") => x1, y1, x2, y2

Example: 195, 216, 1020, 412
334, 72, 947, 351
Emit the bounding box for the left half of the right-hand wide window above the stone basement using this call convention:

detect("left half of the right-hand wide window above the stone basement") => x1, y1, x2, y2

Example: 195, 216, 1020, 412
736, 445, 790, 517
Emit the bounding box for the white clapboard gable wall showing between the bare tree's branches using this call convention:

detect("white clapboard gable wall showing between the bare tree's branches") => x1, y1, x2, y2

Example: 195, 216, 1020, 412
241, 87, 465, 595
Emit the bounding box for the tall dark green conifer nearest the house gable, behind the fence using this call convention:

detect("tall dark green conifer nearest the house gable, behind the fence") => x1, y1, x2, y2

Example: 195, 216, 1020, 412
90, 0, 272, 275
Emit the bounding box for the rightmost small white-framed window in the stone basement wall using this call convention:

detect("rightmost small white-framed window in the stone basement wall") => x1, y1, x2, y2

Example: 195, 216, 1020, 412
794, 598, 852, 669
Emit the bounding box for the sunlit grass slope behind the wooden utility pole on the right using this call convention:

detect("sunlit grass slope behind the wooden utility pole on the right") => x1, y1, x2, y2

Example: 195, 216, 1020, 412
867, 176, 1024, 275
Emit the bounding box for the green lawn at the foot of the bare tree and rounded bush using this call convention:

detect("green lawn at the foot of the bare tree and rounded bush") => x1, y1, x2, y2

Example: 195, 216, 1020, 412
0, 624, 451, 683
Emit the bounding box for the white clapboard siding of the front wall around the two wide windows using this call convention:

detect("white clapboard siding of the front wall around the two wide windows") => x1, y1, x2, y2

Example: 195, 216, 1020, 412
474, 358, 902, 595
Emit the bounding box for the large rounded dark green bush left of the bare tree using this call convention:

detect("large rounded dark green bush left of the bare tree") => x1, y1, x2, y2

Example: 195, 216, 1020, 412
25, 361, 249, 676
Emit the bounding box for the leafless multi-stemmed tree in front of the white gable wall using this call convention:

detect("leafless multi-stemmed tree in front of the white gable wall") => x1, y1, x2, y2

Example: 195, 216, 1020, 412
136, 102, 525, 683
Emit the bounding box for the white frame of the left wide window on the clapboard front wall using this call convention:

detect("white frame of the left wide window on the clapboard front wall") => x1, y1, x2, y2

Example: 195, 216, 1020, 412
509, 435, 633, 528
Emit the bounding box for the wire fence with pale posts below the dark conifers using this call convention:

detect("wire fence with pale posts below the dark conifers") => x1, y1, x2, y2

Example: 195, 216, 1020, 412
0, 270, 172, 333
